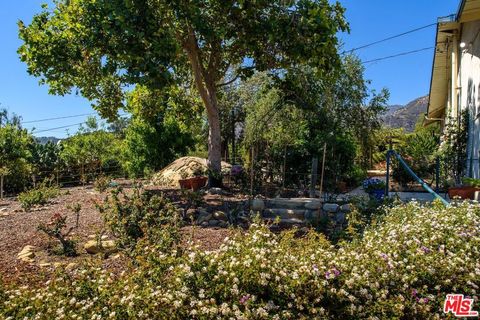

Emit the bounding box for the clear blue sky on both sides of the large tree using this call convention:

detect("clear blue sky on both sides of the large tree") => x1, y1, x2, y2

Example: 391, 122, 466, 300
0, 0, 459, 137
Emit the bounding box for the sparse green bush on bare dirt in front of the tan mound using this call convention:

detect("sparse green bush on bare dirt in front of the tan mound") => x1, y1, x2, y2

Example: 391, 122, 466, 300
97, 187, 180, 251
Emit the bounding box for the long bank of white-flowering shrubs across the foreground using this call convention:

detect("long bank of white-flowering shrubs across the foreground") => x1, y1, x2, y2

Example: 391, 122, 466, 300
0, 203, 480, 319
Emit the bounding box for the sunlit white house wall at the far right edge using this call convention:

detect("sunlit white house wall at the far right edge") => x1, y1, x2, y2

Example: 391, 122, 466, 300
459, 21, 480, 178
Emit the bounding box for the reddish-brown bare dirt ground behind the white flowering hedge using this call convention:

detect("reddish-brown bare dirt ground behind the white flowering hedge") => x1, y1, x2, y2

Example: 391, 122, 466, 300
0, 186, 231, 284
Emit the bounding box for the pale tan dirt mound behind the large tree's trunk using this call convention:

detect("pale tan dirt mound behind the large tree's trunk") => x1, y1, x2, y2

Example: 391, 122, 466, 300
152, 157, 232, 188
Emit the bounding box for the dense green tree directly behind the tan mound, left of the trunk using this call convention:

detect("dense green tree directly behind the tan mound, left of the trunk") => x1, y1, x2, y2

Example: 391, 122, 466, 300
122, 87, 200, 177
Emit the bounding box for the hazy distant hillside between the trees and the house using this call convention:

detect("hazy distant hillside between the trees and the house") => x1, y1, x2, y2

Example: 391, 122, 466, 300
383, 96, 428, 132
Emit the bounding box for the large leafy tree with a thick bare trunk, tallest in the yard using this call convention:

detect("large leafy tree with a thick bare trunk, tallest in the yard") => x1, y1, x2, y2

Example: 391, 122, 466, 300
19, 0, 347, 184
